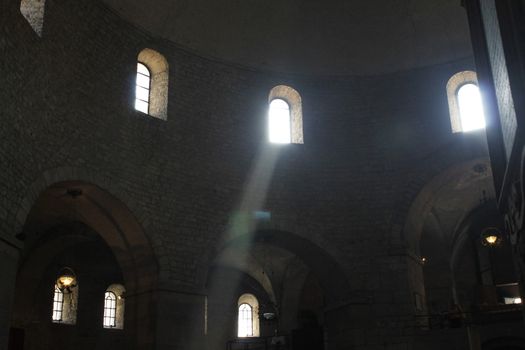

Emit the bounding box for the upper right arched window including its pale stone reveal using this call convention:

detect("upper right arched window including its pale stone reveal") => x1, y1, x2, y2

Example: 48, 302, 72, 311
447, 71, 485, 132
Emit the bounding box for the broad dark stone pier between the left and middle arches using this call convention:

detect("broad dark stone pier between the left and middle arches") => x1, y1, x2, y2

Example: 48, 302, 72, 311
156, 290, 205, 350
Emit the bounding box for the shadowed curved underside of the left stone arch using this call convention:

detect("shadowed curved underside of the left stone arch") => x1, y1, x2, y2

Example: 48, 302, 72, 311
10, 168, 159, 348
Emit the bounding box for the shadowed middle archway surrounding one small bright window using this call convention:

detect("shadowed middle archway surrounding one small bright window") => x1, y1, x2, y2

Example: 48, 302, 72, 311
207, 230, 348, 348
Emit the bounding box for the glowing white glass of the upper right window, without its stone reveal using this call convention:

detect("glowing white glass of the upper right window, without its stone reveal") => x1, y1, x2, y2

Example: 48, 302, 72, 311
457, 83, 485, 131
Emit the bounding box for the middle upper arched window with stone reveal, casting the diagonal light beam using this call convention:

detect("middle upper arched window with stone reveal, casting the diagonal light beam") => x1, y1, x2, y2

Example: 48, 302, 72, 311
268, 85, 304, 144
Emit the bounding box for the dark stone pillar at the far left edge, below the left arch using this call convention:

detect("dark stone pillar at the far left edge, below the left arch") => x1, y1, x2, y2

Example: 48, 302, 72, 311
0, 237, 19, 350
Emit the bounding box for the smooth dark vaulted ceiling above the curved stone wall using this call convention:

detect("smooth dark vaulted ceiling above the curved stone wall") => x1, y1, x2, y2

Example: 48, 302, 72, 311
103, 0, 471, 75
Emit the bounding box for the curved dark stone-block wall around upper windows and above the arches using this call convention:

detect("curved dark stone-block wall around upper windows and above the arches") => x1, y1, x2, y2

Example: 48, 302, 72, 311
0, 0, 492, 349
